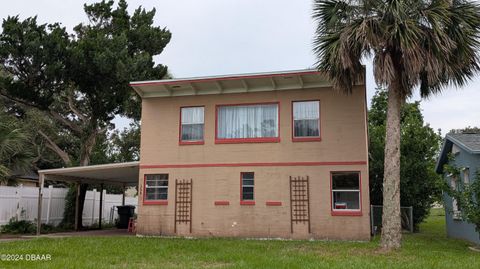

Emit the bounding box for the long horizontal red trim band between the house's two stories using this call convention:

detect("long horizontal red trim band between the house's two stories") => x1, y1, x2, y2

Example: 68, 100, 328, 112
140, 161, 367, 169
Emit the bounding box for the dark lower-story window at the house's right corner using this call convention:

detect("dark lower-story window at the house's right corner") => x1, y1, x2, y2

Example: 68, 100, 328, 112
331, 172, 361, 213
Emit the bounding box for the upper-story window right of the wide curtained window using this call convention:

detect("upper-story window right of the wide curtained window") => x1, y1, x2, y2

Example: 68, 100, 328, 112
292, 101, 320, 141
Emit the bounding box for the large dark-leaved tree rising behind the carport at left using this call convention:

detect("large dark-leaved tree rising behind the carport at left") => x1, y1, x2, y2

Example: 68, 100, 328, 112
0, 0, 171, 226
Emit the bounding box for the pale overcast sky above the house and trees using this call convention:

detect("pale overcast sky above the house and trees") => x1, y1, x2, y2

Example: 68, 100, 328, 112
0, 0, 480, 134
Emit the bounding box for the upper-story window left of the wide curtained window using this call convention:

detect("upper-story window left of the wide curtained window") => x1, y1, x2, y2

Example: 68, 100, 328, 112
180, 106, 204, 144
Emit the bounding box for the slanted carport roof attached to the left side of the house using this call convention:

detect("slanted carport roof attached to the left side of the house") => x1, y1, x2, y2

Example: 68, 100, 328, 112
38, 162, 140, 186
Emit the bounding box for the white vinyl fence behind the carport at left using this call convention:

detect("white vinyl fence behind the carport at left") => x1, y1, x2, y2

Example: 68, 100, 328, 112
0, 186, 138, 226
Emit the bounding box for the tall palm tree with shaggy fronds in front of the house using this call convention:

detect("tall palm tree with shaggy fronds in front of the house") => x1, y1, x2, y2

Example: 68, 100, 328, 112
313, 0, 480, 250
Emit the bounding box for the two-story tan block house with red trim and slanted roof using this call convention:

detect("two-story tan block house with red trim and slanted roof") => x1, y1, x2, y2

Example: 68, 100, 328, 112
131, 70, 370, 240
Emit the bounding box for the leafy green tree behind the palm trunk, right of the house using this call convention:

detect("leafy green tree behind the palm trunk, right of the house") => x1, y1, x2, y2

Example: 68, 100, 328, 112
368, 89, 443, 231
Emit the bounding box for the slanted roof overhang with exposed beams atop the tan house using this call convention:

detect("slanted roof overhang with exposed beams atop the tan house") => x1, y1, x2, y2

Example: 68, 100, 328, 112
130, 69, 364, 98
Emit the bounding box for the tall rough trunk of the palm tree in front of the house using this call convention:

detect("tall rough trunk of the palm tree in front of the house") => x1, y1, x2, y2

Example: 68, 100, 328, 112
380, 81, 405, 251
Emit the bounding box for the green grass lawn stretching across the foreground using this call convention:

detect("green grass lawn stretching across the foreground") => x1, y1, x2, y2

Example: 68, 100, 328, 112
0, 210, 480, 269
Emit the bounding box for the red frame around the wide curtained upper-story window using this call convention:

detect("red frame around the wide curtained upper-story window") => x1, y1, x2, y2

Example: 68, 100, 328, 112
215, 101, 280, 144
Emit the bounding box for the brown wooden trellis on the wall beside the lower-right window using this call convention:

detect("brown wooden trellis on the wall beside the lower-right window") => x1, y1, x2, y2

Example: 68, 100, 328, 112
290, 176, 310, 233
